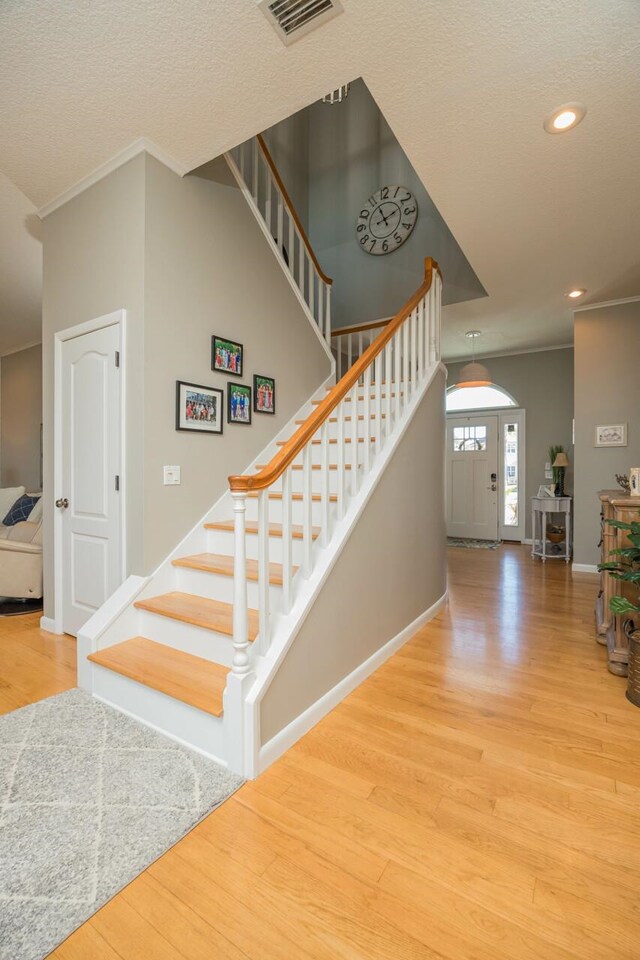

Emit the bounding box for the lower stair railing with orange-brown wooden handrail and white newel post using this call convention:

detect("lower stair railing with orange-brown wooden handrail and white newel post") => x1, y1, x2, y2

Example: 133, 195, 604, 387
229, 257, 442, 680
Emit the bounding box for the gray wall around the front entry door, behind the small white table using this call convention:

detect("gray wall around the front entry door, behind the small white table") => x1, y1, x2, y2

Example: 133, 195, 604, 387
447, 349, 574, 537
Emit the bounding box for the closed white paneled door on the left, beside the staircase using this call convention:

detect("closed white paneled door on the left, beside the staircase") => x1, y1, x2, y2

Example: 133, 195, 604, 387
56, 324, 123, 635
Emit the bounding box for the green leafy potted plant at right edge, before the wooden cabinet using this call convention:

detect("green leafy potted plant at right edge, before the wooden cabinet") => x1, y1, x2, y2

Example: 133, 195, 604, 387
598, 520, 640, 707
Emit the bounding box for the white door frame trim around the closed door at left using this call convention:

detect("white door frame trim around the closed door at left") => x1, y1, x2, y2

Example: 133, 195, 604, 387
52, 310, 129, 633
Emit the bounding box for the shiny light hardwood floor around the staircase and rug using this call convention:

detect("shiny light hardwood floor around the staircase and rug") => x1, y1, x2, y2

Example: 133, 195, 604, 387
0, 546, 640, 960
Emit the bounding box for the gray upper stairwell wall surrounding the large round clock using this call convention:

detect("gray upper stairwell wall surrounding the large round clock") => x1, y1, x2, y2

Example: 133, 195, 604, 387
258, 80, 485, 327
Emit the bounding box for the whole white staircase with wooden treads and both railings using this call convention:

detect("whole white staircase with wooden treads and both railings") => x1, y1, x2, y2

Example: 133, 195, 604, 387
78, 139, 442, 777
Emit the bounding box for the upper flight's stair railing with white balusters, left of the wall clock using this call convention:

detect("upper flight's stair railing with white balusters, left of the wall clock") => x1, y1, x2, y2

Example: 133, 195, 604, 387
227, 134, 333, 346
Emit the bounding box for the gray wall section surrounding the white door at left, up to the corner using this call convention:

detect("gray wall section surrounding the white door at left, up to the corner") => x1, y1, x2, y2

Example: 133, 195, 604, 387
42, 155, 145, 617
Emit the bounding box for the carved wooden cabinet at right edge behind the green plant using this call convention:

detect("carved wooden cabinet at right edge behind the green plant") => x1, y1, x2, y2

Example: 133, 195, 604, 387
595, 490, 640, 677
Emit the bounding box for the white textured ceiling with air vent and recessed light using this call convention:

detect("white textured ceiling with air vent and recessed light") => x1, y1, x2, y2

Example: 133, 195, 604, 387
0, 0, 640, 356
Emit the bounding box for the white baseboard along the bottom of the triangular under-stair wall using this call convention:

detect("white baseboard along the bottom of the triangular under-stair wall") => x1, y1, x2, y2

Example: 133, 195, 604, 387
258, 591, 448, 773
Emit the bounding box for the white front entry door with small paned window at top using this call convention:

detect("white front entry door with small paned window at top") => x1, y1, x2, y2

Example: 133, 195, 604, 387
445, 416, 498, 540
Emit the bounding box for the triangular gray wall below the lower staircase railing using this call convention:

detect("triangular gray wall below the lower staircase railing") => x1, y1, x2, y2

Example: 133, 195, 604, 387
261, 374, 446, 743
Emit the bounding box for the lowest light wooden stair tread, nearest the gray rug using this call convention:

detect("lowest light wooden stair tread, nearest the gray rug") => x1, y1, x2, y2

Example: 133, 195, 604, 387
87, 637, 229, 717
